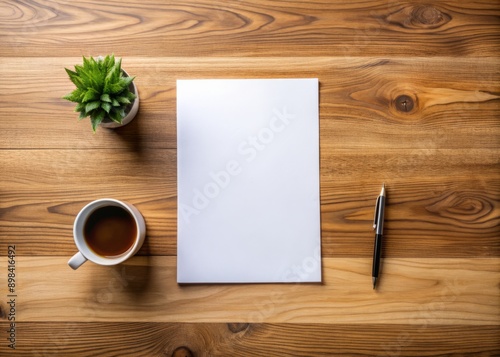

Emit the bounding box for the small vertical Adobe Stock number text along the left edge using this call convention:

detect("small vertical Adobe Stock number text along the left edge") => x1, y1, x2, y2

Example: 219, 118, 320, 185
7, 245, 17, 350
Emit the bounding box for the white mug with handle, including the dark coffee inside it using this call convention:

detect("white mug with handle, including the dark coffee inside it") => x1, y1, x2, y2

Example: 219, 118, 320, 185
68, 198, 146, 269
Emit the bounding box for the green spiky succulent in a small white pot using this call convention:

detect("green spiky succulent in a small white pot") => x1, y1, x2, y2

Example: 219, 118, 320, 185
63, 55, 139, 133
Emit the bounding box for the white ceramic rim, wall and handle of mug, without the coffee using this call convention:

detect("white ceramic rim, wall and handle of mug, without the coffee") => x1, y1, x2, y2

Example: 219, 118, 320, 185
68, 198, 146, 269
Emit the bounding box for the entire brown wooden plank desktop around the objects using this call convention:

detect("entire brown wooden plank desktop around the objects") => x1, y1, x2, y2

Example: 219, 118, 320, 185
0, 0, 500, 356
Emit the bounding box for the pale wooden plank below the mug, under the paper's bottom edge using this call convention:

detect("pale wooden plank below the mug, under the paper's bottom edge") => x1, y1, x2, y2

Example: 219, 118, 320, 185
0, 256, 500, 326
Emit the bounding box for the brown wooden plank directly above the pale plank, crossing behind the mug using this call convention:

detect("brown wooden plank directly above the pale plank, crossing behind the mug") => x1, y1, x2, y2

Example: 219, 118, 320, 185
0, 149, 500, 258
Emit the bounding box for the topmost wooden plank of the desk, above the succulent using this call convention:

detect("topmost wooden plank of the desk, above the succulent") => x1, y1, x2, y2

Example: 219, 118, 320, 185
0, 0, 500, 57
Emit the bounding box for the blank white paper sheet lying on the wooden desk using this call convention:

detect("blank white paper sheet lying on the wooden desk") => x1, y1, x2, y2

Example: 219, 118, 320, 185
177, 79, 321, 283
